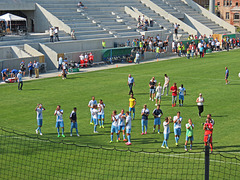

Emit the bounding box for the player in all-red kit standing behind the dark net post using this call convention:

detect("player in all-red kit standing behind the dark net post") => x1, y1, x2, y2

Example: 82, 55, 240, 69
203, 118, 213, 153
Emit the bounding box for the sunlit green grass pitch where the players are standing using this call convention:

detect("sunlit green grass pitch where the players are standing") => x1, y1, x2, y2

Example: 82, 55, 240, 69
0, 50, 240, 179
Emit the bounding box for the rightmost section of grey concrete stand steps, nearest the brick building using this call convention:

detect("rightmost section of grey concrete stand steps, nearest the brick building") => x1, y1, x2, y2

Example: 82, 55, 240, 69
152, 0, 231, 34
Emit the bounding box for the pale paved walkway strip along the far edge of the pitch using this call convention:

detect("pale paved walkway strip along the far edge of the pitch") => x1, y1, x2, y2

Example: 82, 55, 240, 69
0, 55, 178, 84
